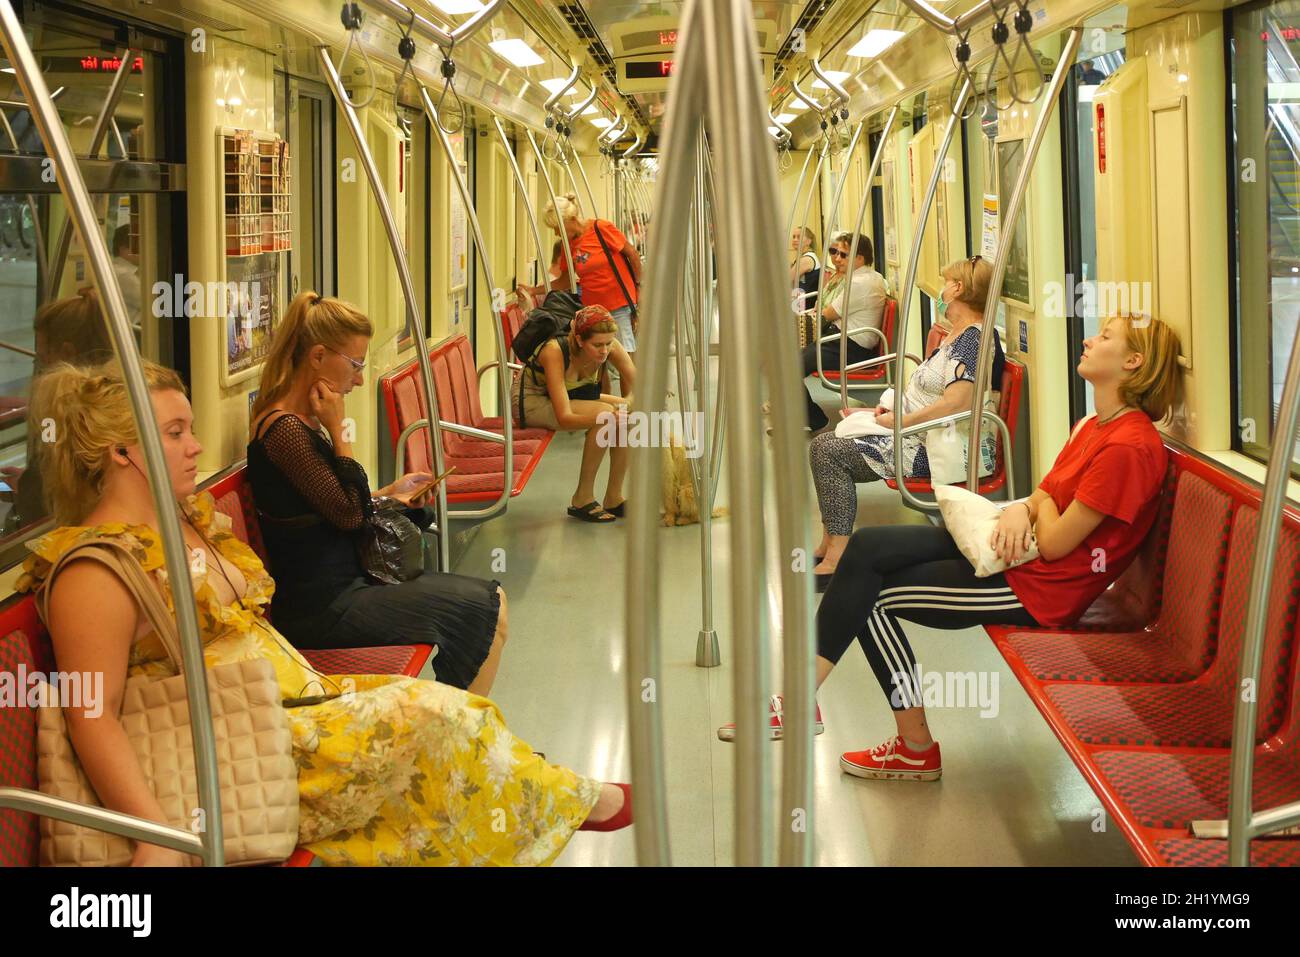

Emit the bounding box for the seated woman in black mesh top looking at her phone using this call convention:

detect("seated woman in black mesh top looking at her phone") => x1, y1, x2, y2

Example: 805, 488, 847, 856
248, 293, 506, 694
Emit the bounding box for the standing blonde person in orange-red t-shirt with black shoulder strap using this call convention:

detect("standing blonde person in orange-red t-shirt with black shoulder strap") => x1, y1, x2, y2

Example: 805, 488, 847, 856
523, 192, 641, 361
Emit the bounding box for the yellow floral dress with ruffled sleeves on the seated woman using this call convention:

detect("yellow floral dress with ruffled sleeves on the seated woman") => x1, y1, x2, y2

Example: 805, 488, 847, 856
17, 493, 601, 865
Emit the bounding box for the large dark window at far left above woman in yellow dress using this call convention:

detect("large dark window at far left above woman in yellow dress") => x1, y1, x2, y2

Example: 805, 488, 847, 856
0, 3, 189, 566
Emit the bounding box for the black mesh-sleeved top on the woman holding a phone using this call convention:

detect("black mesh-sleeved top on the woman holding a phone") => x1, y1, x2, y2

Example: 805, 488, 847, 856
248, 413, 372, 631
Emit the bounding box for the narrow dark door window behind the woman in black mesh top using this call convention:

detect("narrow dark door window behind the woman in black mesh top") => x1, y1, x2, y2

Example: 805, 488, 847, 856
283, 73, 337, 303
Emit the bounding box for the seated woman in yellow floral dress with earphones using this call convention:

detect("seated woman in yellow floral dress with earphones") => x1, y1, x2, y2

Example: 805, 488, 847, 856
18, 365, 631, 865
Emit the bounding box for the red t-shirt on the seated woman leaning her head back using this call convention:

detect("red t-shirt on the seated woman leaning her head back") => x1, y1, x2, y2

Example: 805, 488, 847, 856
1006, 412, 1169, 627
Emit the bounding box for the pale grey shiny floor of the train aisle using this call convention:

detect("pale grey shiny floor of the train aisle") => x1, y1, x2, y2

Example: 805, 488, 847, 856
456, 379, 1136, 866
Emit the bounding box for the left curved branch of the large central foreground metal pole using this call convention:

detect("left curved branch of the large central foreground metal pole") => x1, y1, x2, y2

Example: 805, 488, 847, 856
624, 7, 707, 866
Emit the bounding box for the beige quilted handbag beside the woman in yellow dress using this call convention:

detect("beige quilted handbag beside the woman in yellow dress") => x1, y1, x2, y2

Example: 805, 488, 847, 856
36, 540, 298, 866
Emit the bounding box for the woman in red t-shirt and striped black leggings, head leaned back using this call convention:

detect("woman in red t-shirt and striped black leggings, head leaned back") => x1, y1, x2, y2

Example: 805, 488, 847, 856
724, 317, 1182, 780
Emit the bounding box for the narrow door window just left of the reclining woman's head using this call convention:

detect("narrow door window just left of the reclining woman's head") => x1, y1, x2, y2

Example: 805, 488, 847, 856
1061, 7, 1127, 421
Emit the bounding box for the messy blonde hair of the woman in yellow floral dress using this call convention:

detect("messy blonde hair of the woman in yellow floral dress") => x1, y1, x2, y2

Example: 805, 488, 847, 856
31, 359, 185, 525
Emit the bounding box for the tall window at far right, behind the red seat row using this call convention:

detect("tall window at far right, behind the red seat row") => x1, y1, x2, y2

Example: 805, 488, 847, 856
1229, 0, 1300, 460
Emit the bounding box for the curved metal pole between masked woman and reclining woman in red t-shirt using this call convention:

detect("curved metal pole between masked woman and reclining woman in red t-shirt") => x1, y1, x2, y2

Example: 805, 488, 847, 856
961, 26, 1083, 492
